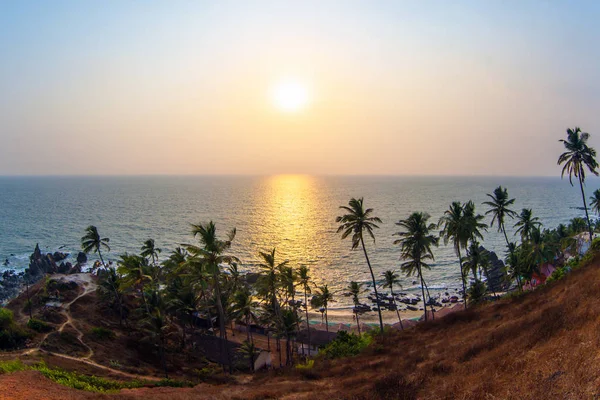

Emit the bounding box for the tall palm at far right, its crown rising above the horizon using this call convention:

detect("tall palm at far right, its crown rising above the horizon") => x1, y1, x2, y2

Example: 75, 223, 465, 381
557, 127, 598, 242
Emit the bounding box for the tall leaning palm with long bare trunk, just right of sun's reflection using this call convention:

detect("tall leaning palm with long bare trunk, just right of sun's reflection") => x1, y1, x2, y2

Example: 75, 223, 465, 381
335, 197, 383, 333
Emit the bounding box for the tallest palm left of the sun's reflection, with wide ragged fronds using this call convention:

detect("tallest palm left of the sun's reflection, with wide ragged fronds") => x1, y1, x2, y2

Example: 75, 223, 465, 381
187, 221, 239, 373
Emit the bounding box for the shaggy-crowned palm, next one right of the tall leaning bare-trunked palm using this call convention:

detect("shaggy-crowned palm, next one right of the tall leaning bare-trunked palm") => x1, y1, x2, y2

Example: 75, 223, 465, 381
394, 212, 438, 321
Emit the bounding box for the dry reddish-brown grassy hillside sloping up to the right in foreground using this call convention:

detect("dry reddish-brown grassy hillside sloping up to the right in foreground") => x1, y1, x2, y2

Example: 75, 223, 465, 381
0, 258, 600, 400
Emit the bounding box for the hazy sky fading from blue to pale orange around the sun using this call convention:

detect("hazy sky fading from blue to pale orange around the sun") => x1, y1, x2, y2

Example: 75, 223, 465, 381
0, 0, 600, 175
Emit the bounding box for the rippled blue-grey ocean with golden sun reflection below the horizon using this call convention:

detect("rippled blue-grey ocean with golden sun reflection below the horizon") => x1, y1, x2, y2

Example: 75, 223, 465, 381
0, 175, 600, 309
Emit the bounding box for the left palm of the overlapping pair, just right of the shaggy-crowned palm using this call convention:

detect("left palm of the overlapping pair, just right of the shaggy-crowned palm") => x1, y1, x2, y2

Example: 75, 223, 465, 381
438, 201, 472, 308
